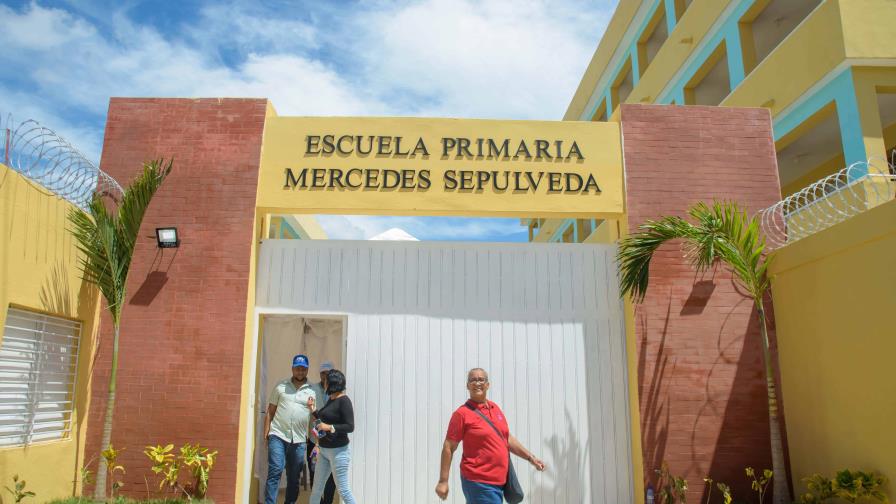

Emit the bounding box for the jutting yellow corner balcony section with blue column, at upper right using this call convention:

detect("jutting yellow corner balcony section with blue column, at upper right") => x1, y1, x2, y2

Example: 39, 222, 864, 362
721, 0, 896, 196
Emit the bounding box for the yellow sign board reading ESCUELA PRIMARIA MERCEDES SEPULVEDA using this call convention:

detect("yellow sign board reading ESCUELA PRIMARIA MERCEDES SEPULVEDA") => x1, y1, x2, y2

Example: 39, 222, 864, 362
258, 115, 624, 218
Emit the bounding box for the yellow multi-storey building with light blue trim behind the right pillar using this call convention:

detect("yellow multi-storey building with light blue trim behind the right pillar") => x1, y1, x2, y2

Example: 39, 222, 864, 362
523, 0, 896, 242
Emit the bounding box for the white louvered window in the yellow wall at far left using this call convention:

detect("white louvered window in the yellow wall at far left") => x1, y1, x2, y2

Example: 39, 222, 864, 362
0, 307, 81, 446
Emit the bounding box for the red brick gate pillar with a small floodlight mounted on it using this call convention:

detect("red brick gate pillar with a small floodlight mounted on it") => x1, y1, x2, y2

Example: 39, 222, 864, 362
86, 98, 267, 504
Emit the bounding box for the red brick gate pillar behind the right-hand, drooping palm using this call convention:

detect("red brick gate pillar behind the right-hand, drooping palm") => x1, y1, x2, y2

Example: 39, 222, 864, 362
621, 105, 780, 501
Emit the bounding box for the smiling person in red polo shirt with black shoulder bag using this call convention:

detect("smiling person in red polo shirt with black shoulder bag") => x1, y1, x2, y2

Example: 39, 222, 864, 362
436, 368, 544, 504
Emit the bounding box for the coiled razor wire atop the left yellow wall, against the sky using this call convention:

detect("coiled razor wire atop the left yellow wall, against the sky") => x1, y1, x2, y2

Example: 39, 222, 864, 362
0, 114, 122, 209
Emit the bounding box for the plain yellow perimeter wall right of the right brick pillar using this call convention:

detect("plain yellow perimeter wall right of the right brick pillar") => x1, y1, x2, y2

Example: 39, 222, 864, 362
772, 200, 896, 499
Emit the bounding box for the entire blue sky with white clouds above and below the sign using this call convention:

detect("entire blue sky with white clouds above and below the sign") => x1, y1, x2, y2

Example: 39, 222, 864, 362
0, 0, 616, 241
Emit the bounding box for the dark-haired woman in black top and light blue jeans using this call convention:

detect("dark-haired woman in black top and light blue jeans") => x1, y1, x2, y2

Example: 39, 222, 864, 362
308, 369, 355, 504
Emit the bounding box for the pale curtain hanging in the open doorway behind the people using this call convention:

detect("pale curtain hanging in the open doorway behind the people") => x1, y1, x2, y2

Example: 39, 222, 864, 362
254, 315, 344, 502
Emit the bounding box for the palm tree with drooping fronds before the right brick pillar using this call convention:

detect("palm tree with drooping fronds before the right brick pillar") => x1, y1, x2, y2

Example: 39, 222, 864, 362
617, 203, 790, 504
